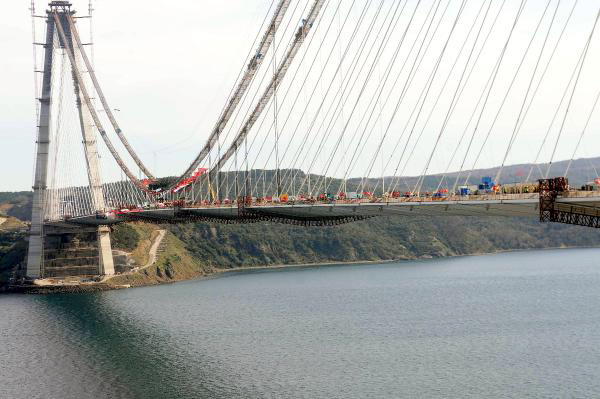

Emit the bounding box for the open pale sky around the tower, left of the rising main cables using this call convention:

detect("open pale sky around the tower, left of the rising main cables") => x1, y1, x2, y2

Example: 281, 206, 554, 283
0, 0, 271, 191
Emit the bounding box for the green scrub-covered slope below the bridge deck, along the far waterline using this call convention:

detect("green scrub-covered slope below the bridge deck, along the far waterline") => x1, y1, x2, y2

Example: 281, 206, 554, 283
169, 217, 600, 268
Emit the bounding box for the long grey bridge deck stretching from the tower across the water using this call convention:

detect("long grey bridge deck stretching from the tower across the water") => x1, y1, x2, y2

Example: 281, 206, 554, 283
46, 192, 600, 228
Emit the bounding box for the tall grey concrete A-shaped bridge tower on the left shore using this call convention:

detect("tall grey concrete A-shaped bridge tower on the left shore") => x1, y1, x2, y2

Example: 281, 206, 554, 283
26, 1, 114, 279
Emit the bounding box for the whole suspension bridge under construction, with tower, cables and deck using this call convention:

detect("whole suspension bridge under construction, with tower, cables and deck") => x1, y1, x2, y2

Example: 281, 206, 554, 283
27, 0, 600, 278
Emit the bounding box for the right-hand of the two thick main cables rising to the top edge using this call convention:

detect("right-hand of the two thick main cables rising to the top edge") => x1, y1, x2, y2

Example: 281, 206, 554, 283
209, 0, 325, 180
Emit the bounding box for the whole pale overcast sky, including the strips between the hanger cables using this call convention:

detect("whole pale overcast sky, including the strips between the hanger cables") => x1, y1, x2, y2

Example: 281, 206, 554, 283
0, 0, 600, 191
